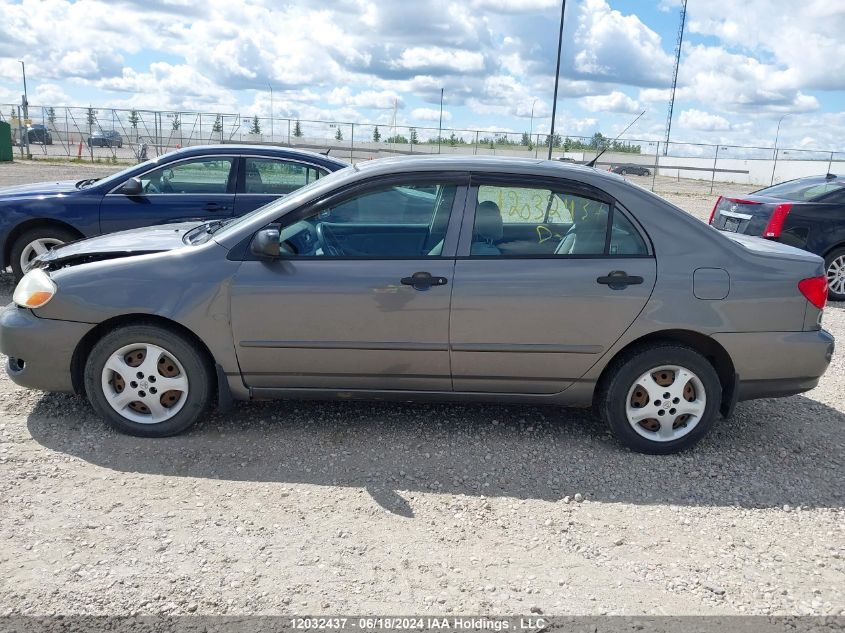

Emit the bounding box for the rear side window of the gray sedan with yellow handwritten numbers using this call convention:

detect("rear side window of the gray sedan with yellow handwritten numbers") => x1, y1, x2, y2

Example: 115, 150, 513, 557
470, 185, 648, 257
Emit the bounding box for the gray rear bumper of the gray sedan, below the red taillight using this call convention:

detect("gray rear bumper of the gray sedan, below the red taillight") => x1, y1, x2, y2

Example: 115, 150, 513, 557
713, 330, 834, 400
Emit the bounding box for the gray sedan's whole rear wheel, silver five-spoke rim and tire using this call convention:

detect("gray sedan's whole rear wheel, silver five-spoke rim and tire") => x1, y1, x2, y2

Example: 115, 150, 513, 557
598, 343, 722, 455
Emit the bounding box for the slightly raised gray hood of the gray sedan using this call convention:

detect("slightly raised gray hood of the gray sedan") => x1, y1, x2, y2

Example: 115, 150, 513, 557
30, 222, 202, 270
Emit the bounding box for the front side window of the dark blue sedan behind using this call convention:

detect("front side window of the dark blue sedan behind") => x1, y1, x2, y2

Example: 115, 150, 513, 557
141, 156, 234, 194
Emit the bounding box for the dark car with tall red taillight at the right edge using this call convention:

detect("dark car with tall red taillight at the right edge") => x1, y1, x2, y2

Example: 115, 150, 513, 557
710, 174, 845, 301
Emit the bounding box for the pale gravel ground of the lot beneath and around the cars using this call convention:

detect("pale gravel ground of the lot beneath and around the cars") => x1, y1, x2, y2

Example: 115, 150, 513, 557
0, 163, 845, 615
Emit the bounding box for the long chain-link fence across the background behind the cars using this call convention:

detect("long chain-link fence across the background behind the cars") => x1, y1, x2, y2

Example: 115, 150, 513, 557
0, 104, 845, 193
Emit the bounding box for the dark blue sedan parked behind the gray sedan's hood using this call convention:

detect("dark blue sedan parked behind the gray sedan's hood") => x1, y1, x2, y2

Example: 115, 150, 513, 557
0, 145, 347, 278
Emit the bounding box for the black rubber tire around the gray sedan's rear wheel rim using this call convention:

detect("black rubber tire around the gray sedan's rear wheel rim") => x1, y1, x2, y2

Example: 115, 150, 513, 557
596, 342, 722, 455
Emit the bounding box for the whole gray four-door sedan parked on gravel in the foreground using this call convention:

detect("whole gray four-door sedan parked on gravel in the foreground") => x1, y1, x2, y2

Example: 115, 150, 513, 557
0, 157, 834, 453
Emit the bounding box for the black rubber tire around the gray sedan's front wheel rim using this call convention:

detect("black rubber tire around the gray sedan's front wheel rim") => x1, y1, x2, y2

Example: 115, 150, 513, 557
85, 324, 214, 437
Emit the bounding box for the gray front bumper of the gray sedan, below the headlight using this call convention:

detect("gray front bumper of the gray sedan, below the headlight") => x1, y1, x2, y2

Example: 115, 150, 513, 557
0, 304, 95, 392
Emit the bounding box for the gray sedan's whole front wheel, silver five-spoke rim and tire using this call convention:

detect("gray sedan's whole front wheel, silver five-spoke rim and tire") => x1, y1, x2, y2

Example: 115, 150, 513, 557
85, 325, 213, 437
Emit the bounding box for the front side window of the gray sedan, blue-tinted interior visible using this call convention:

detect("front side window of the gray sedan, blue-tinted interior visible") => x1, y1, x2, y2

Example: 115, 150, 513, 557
280, 184, 457, 259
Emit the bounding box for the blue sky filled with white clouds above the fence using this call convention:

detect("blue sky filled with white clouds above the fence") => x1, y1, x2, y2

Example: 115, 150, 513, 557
0, 0, 845, 150
